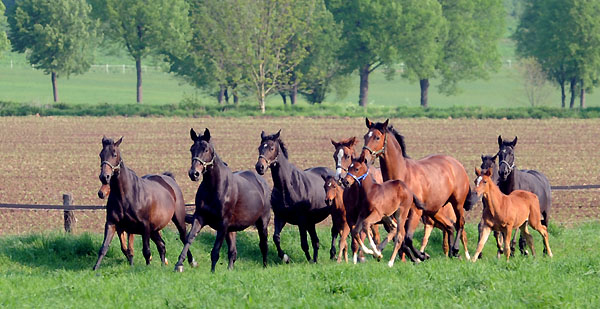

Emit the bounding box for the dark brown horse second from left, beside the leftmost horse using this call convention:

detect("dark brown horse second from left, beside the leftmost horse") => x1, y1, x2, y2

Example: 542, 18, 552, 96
175, 128, 271, 272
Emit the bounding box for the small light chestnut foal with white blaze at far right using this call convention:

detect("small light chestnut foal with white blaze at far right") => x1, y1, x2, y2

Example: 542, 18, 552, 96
472, 168, 552, 262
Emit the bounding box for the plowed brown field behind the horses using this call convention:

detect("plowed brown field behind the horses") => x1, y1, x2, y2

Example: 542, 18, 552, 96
0, 117, 600, 234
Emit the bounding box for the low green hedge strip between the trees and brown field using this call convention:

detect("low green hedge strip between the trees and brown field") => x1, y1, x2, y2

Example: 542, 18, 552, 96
0, 100, 600, 119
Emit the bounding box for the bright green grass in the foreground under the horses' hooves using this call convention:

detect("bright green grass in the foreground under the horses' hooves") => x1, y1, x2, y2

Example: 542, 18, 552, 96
0, 223, 600, 308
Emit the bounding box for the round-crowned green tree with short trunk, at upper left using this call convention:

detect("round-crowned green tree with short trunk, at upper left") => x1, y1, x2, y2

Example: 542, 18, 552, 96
8, 0, 97, 102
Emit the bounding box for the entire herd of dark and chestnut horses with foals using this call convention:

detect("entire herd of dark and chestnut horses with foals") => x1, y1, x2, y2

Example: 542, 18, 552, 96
93, 118, 552, 272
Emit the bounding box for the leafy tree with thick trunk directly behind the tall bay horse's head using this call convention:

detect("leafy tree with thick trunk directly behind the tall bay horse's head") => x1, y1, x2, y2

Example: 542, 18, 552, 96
325, 0, 403, 106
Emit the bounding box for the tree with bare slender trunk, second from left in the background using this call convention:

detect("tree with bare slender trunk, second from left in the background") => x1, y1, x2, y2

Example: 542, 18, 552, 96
90, 0, 189, 103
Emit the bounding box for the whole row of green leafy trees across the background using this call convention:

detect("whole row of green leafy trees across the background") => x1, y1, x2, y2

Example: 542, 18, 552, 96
0, 0, 600, 112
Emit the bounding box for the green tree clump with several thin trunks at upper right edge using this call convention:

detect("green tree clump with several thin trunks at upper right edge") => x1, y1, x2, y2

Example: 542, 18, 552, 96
514, 0, 600, 108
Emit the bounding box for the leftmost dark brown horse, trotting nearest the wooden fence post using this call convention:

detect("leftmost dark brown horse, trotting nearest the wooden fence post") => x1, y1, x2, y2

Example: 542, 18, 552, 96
93, 137, 196, 270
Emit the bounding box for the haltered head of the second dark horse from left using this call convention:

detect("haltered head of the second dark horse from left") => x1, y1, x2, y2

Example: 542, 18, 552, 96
188, 128, 215, 181
